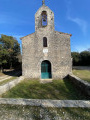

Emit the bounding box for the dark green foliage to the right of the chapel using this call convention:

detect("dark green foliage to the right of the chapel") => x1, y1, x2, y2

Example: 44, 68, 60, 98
71, 49, 90, 66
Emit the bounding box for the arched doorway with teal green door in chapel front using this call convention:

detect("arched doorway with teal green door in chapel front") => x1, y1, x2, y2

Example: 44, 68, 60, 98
41, 60, 52, 79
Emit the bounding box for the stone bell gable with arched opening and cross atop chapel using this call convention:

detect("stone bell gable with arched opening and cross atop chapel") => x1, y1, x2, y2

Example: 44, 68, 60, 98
35, 0, 54, 31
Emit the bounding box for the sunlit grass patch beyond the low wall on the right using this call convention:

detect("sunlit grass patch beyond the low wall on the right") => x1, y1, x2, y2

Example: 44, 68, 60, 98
73, 70, 90, 83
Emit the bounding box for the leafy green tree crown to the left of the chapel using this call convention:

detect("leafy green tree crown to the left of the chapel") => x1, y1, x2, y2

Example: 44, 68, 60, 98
0, 34, 20, 71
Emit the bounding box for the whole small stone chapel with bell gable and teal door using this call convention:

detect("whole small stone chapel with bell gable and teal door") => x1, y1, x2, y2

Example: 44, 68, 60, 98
21, 0, 72, 80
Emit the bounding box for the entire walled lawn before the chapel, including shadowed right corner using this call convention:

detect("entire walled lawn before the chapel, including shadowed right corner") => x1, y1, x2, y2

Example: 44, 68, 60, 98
1, 79, 89, 100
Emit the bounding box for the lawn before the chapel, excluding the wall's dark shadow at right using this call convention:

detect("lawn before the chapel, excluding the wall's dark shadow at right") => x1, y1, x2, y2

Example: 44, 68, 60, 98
2, 80, 75, 100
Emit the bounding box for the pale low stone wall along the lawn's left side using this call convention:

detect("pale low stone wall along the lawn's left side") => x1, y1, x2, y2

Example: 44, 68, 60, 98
0, 76, 24, 95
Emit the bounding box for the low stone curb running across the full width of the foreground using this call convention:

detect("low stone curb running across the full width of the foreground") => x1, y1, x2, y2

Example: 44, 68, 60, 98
0, 98, 90, 108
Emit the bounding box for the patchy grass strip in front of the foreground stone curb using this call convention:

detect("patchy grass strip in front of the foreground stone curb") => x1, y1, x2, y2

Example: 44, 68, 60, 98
0, 105, 90, 120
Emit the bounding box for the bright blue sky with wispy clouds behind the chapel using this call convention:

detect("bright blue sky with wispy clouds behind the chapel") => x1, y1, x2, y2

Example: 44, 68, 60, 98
0, 0, 90, 52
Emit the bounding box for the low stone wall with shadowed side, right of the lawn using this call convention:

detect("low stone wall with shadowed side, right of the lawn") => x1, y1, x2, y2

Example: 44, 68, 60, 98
68, 75, 90, 96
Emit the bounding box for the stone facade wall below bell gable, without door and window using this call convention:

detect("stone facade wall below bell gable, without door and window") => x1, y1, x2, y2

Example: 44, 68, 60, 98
22, 31, 72, 79
